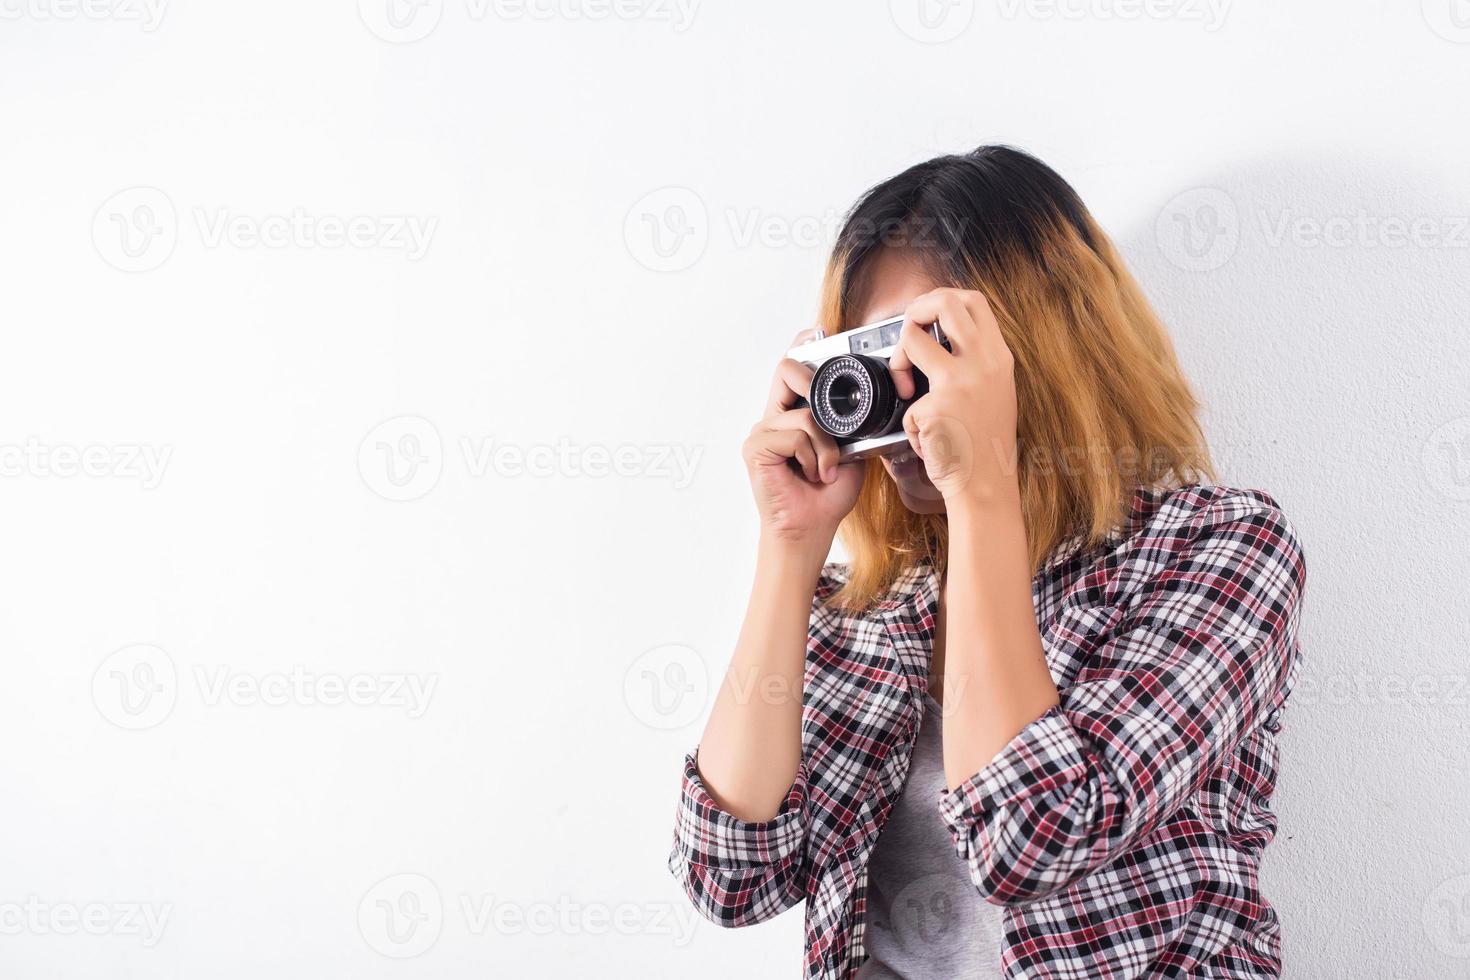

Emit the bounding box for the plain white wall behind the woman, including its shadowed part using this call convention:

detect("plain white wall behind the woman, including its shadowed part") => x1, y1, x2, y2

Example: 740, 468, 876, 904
0, 0, 1470, 979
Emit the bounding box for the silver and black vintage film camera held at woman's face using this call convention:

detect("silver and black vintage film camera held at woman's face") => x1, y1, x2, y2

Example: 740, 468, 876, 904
786, 316, 950, 460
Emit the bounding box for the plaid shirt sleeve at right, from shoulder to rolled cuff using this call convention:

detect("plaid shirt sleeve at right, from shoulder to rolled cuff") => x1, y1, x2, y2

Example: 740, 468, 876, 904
939, 492, 1305, 905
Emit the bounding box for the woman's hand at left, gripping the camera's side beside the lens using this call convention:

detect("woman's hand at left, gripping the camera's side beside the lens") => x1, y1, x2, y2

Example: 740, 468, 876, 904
744, 334, 866, 554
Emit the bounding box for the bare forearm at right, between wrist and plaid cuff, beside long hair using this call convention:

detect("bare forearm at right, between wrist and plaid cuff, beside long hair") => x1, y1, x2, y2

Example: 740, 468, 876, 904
944, 486, 1058, 789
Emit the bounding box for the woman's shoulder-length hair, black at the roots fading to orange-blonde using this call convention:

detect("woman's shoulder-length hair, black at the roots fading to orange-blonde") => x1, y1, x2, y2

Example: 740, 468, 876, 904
820, 145, 1213, 608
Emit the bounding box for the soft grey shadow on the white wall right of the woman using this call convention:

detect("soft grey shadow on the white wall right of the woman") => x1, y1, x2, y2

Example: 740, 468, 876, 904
1119, 159, 1470, 977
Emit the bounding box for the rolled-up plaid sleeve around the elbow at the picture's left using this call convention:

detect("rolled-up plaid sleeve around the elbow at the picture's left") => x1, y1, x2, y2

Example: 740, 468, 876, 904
669, 755, 807, 926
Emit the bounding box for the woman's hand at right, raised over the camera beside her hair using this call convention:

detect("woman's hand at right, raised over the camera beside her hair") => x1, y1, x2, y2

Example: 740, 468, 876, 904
888, 289, 1017, 508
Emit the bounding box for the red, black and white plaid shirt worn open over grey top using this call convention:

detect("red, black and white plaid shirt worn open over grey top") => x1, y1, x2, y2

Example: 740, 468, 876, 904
669, 486, 1304, 980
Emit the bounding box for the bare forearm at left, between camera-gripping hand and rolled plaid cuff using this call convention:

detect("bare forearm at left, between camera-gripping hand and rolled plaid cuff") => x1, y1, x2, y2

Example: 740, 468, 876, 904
698, 536, 831, 821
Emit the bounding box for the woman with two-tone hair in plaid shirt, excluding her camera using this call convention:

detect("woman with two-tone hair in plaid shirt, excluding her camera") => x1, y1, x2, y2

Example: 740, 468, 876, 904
670, 147, 1304, 980
